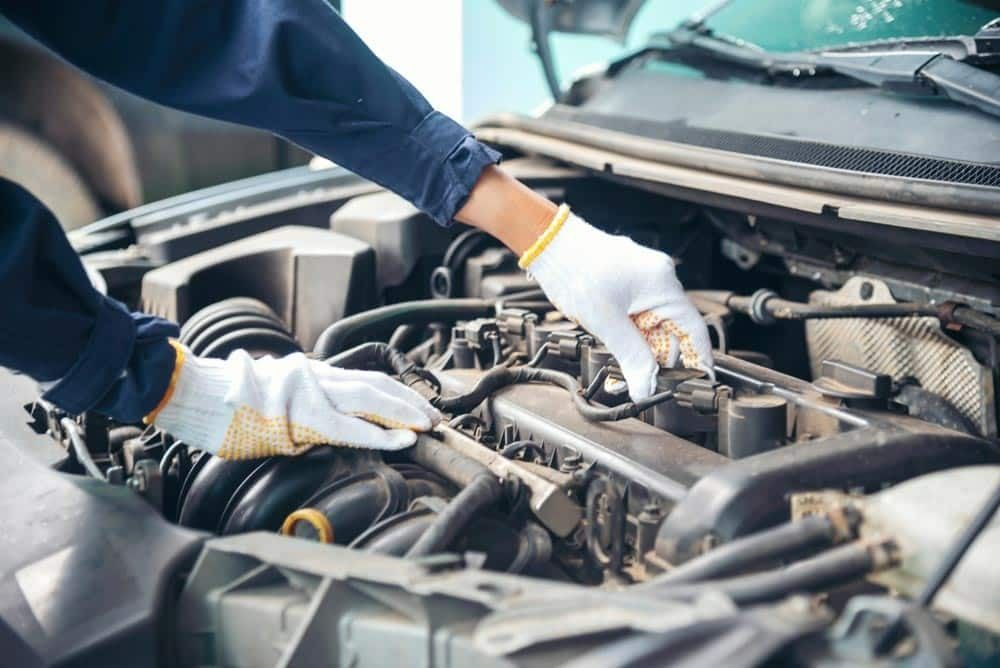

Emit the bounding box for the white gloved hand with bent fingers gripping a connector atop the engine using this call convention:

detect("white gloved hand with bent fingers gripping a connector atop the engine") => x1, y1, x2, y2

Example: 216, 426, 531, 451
520, 205, 712, 401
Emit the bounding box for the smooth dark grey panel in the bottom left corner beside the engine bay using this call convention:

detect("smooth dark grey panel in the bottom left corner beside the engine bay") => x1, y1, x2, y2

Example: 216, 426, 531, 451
0, 432, 203, 668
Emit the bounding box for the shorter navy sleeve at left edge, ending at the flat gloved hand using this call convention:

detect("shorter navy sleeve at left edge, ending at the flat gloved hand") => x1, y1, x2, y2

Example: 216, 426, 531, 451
0, 179, 177, 422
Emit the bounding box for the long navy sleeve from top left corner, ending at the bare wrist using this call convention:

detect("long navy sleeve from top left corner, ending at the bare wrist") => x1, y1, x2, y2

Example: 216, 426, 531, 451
0, 0, 500, 225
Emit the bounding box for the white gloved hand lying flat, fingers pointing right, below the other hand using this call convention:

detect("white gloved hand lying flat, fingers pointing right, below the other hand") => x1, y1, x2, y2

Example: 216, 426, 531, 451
146, 341, 440, 459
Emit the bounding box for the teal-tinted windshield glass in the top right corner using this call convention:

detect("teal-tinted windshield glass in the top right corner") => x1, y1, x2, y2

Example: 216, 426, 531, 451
706, 0, 1000, 51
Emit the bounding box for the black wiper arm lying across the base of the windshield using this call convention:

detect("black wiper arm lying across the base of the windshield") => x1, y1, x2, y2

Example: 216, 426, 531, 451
652, 27, 1000, 121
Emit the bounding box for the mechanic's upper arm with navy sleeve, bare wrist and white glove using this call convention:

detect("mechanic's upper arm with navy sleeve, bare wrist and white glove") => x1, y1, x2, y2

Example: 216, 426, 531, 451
0, 0, 710, 460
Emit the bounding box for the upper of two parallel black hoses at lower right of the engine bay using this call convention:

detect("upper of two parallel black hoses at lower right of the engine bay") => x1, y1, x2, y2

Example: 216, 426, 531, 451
648, 515, 837, 587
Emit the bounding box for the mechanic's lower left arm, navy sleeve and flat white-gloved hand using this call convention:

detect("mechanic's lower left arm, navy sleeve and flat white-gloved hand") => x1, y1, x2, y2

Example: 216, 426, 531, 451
0, 178, 438, 459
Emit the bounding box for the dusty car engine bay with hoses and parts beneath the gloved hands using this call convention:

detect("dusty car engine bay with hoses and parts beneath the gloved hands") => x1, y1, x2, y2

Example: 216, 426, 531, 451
23, 159, 1000, 665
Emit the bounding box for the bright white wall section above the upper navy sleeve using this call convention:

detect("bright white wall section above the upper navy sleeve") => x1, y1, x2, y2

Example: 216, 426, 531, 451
341, 0, 463, 119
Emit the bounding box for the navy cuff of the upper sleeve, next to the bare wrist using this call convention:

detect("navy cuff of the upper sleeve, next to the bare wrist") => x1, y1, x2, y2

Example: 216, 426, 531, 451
410, 111, 502, 227
